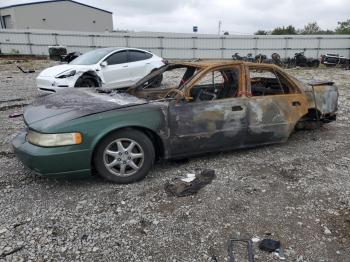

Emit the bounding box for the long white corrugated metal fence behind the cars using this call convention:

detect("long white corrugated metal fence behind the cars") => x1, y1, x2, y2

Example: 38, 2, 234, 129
0, 30, 350, 59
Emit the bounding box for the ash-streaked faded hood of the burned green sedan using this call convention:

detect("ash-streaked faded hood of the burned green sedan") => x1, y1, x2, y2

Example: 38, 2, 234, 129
23, 88, 148, 126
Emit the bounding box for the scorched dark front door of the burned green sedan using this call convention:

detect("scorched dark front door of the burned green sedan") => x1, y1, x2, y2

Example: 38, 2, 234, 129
169, 68, 247, 157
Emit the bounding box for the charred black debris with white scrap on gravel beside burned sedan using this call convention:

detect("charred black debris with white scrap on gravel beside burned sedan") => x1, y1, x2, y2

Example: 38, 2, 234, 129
164, 169, 215, 197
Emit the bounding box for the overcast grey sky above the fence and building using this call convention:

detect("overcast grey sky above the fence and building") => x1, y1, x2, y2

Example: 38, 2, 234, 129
0, 0, 350, 34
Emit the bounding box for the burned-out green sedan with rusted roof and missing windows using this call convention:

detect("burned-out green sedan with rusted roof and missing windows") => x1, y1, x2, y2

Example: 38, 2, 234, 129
12, 61, 338, 183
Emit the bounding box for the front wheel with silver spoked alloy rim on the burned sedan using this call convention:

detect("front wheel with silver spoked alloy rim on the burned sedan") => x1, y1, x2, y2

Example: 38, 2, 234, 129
93, 129, 155, 184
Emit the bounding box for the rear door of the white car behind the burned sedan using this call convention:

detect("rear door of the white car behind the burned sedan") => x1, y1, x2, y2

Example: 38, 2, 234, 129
128, 49, 152, 83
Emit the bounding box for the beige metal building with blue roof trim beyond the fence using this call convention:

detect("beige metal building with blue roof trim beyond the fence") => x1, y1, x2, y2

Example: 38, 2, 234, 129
0, 0, 113, 32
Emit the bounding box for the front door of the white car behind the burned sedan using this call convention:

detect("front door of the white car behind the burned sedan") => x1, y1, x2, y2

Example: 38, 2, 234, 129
101, 50, 133, 88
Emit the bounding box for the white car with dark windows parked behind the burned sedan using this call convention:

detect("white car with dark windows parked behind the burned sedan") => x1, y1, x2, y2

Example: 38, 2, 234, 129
36, 48, 166, 92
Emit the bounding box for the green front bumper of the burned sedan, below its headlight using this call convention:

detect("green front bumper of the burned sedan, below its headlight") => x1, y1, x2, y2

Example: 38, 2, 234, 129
12, 130, 91, 176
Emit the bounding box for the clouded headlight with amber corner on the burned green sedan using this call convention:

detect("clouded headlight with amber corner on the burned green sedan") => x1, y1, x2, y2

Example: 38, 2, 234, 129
27, 130, 83, 147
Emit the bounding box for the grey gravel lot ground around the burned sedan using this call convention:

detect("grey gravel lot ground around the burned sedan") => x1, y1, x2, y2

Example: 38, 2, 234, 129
0, 61, 350, 262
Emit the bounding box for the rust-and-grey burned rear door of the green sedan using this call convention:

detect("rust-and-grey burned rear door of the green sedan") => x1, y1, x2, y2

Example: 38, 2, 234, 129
246, 65, 308, 146
